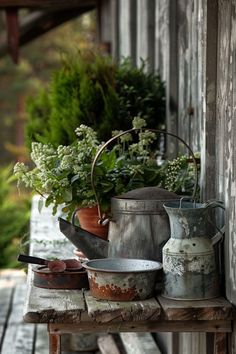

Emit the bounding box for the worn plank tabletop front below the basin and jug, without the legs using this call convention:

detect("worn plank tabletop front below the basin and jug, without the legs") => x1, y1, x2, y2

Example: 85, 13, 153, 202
24, 283, 233, 333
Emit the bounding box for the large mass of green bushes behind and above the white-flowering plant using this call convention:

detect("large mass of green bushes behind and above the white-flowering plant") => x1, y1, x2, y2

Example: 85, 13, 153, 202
26, 52, 165, 147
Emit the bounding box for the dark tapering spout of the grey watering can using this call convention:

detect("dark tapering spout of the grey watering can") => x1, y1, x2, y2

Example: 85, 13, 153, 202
58, 217, 108, 259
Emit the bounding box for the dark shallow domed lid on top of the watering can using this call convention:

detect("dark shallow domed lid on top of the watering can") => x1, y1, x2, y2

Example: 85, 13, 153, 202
115, 187, 180, 200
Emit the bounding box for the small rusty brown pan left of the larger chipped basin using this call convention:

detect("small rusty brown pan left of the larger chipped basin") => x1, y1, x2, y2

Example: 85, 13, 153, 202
33, 266, 89, 289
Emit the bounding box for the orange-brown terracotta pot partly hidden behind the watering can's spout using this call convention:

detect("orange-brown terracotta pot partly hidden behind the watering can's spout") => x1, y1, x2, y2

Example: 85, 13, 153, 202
76, 206, 108, 240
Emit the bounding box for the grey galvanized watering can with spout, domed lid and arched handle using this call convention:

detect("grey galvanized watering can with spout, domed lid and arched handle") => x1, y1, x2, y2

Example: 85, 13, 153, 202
59, 128, 197, 262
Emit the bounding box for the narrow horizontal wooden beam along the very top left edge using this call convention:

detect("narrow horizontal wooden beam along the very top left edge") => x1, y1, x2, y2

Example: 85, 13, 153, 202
0, 0, 96, 9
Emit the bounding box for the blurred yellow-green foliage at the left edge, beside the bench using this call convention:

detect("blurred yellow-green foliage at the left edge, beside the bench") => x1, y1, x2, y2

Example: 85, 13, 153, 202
0, 166, 30, 268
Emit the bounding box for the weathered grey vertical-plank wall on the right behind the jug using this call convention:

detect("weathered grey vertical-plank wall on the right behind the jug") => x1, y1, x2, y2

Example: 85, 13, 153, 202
99, 0, 236, 353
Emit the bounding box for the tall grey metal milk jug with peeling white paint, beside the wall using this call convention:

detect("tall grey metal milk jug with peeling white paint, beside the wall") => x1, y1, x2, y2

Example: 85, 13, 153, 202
162, 201, 224, 300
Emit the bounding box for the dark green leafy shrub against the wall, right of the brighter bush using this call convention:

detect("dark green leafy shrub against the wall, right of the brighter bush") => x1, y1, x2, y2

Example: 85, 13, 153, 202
116, 59, 165, 130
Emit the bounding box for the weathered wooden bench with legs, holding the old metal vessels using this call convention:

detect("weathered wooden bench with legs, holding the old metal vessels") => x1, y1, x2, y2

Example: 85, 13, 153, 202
24, 196, 233, 354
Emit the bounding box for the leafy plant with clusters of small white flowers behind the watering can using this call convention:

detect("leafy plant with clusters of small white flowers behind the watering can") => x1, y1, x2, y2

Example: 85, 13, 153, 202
14, 117, 197, 218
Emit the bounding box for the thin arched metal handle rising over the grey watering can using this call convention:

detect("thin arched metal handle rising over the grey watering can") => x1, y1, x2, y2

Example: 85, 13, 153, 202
91, 128, 198, 224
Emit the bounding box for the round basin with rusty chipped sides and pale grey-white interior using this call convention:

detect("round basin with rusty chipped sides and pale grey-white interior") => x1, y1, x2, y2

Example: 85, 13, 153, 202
84, 258, 162, 301
